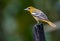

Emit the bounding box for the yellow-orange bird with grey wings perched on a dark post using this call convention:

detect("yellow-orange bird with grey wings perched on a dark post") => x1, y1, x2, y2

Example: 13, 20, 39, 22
24, 6, 56, 27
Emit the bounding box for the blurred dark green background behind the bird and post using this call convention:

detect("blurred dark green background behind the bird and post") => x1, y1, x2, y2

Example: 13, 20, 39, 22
0, 0, 60, 41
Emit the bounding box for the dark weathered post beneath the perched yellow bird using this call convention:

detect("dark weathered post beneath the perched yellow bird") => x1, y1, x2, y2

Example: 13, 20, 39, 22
33, 23, 45, 41
